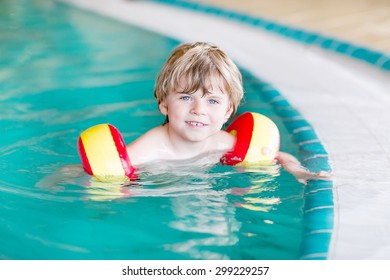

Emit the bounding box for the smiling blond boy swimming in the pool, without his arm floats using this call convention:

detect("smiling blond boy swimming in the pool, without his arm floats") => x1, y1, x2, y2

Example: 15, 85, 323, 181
127, 42, 328, 181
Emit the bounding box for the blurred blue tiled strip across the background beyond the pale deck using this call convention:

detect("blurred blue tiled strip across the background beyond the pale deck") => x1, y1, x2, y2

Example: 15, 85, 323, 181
151, 0, 390, 71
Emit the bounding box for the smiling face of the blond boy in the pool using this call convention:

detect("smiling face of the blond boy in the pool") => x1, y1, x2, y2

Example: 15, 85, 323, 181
159, 76, 233, 142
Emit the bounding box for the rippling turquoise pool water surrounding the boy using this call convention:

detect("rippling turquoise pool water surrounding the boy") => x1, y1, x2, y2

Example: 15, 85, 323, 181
0, 0, 304, 259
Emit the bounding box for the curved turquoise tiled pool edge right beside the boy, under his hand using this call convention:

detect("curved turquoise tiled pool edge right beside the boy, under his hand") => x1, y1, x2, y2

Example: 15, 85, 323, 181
241, 69, 334, 260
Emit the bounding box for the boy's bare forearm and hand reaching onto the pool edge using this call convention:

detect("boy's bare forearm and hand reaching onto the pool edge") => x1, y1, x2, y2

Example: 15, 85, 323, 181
276, 152, 331, 183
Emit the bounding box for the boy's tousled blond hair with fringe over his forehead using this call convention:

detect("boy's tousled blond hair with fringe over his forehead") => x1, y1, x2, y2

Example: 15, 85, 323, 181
154, 42, 244, 116
